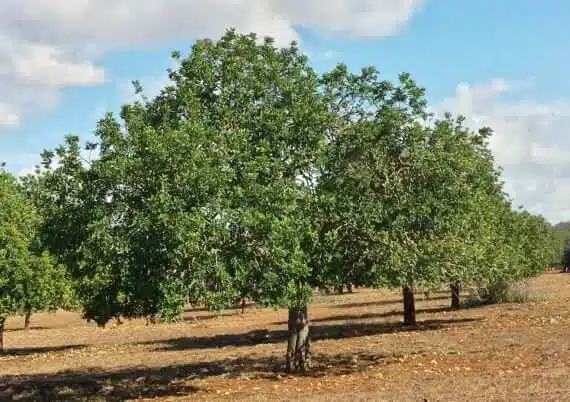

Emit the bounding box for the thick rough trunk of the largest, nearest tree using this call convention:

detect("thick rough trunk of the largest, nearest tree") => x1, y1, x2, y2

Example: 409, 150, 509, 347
287, 306, 311, 372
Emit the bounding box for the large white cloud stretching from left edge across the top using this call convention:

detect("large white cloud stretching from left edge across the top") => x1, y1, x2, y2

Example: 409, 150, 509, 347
0, 0, 423, 129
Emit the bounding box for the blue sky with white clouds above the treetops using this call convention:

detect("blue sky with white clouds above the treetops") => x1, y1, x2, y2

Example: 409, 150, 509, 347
0, 0, 570, 223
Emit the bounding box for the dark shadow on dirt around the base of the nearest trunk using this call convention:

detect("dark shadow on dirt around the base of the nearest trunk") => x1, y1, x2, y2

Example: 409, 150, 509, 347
0, 352, 430, 402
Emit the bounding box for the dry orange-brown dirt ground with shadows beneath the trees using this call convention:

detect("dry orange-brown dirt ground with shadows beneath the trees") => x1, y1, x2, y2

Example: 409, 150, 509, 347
0, 273, 570, 401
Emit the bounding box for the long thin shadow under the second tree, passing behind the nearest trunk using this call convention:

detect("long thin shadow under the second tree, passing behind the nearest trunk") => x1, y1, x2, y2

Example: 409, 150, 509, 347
140, 318, 480, 351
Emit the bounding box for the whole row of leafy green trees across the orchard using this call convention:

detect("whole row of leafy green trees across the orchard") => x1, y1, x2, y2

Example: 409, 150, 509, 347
0, 30, 552, 370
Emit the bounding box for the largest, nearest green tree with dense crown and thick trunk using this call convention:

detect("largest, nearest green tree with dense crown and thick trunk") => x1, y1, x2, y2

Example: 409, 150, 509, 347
36, 30, 330, 369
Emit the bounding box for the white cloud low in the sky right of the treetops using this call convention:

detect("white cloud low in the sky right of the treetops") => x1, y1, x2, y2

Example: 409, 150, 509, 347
435, 79, 570, 221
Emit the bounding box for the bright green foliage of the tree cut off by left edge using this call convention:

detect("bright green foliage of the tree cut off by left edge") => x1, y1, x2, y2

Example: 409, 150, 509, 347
0, 171, 74, 321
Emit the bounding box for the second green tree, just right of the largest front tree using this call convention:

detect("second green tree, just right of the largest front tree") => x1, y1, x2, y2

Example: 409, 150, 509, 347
315, 65, 516, 325
